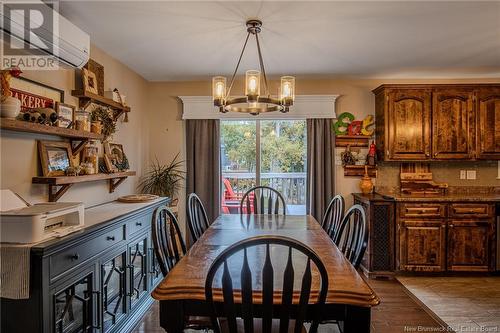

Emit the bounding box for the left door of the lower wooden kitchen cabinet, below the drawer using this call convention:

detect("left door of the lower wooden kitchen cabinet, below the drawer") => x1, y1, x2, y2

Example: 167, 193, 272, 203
398, 220, 446, 272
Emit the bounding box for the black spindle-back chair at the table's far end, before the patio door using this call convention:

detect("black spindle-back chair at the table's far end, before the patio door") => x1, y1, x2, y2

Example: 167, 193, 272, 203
240, 186, 286, 215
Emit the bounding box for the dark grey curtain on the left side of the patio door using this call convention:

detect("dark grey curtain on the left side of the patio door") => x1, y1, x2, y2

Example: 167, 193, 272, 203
186, 119, 221, 244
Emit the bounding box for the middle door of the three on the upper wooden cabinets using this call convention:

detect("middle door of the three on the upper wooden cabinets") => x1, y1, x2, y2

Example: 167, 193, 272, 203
432, 88, 475, 160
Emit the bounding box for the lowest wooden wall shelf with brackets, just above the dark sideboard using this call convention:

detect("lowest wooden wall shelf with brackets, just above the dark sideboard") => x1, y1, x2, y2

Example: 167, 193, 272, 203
32, 171, 136, 202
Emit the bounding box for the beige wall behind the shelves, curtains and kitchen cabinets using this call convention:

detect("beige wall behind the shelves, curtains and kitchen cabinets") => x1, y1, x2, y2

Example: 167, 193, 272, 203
0, 47, 500, 225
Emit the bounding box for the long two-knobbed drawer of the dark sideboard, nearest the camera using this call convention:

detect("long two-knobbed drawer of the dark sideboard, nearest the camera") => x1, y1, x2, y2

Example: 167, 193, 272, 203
50, 224, 125, 279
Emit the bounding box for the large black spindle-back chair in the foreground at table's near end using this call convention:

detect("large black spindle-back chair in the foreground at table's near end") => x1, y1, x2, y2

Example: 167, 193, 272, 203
205, 235, 328, 333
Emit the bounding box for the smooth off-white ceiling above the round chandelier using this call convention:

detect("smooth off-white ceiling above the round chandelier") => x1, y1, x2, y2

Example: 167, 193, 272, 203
60, 1, 500, 81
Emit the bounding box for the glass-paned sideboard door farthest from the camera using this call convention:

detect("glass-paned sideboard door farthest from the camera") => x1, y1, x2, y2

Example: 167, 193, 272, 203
129, 236, 148, 307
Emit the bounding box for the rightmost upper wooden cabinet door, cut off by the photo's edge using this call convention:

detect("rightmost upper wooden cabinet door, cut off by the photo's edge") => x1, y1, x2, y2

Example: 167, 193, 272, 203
476, 87, 500, 159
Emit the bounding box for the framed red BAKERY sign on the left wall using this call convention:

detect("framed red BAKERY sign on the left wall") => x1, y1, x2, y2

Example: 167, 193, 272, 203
10, 77, 64, 112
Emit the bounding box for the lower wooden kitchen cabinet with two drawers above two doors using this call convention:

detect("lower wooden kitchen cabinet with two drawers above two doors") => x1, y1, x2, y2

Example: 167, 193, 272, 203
396, 201, 496, 272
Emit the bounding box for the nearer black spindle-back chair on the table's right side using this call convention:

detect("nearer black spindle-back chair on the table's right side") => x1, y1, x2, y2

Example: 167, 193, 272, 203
333, 205, 368, 269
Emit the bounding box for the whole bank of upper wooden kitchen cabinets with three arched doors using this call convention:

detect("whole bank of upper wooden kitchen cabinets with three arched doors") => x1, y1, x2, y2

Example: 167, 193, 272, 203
373, 84, 500, 161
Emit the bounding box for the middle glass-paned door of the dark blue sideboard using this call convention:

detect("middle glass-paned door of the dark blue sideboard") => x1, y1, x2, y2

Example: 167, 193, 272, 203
101, 251, 127, 332
